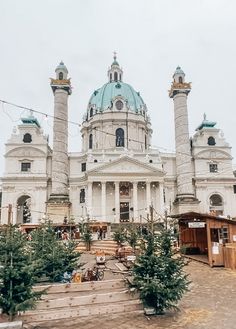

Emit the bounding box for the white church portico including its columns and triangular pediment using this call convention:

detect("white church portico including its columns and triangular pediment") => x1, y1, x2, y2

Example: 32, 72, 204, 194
72, 156, 164, 223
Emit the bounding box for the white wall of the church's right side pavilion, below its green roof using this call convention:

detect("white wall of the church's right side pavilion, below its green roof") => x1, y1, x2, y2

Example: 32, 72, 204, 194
192, 127, 236, 217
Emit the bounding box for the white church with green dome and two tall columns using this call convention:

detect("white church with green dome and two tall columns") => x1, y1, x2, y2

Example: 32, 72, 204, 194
1, 56, 236, 224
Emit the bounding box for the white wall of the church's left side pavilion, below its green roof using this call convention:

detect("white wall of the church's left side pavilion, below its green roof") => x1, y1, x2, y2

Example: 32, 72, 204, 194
1, 124, 51, 224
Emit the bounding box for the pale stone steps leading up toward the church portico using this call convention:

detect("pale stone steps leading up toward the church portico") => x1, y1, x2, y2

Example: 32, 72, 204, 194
76, 240, 118, 255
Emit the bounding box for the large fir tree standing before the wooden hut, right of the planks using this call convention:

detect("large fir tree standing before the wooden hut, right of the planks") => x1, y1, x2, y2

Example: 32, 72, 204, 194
133, 229, 189, 314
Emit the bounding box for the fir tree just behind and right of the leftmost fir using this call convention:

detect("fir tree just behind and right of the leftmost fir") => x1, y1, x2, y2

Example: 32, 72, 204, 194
30, 223, 80, 282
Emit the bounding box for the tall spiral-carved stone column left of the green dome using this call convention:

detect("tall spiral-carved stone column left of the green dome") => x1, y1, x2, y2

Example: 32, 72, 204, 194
47, 62, 71, 221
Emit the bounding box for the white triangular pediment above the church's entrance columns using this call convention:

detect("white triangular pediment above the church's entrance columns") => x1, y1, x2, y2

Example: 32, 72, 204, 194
88, 156, 164, 177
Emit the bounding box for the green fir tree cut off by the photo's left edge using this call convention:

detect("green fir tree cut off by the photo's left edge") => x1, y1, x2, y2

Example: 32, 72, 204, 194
0, 225, 44, 320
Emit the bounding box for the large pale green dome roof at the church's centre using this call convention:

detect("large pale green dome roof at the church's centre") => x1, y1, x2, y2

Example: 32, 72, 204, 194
89, 81, 146, 112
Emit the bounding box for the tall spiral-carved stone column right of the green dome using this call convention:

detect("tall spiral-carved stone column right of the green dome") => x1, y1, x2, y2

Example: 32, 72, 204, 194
169, 66, 199, 213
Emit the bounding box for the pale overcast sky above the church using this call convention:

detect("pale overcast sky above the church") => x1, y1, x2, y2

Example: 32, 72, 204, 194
0, 0, 236, 176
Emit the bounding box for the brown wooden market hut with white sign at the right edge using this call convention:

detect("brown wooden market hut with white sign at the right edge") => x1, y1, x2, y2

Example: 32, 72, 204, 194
172, 212, 236, 269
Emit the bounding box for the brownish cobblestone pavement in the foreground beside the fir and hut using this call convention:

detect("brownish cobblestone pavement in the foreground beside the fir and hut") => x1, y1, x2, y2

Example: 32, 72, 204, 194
29, 261, 236, 329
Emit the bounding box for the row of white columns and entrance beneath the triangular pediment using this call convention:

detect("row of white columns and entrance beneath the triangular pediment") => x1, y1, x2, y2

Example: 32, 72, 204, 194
77, 180, 164, 223
